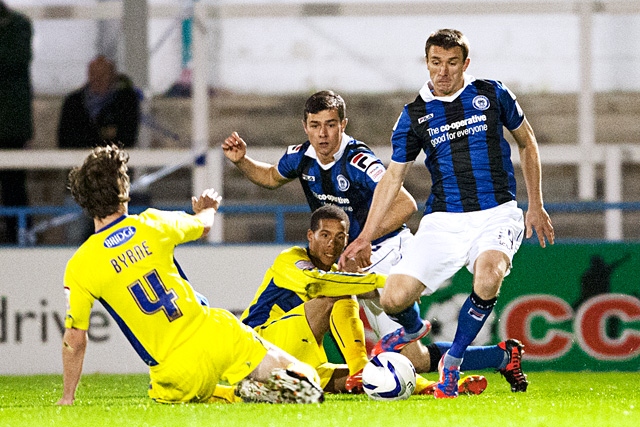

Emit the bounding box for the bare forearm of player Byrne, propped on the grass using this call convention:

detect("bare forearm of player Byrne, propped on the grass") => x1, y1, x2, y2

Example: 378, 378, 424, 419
58, 328, 87, 405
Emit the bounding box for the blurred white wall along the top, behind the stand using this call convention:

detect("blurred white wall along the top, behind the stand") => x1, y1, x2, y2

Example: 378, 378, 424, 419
15, 0, 640, 94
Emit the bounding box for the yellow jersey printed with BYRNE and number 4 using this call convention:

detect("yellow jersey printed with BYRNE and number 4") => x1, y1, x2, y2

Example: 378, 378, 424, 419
64, 209, 208, 366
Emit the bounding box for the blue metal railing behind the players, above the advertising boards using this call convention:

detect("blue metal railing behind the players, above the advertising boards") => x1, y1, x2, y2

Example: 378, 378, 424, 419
0, 202, 640, 246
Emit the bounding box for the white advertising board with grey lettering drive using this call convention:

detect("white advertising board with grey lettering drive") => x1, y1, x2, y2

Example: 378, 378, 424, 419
0, 245, 287, 375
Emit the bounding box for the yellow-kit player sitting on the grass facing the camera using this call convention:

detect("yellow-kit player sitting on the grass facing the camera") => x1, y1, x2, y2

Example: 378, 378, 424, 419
240, 205, 386, 392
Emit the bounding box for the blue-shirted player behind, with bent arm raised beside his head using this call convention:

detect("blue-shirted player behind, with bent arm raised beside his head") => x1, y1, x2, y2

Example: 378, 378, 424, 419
222, 90, 428, 364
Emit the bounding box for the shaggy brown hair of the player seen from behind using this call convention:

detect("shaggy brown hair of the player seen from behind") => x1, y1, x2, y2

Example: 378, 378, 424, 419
67, 144, 130, 218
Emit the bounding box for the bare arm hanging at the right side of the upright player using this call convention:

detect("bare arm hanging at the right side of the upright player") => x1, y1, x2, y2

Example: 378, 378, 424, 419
511, 118, 555, 248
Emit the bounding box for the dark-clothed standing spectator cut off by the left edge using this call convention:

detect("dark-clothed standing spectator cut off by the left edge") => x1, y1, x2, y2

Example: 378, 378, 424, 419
0, 0, 33, 244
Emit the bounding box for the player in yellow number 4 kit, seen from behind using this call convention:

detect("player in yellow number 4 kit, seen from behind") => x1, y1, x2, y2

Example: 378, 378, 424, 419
58, 145, 323, 405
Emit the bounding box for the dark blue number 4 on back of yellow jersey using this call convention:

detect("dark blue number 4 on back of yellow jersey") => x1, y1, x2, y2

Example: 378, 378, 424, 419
129, 270, 182, 322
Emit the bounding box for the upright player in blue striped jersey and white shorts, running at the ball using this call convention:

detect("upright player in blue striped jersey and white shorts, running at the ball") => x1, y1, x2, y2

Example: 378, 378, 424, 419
340, 29, 554, 398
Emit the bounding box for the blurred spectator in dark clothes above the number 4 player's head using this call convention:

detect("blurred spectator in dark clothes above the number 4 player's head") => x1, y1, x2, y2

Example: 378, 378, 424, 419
58, 55, 140, 148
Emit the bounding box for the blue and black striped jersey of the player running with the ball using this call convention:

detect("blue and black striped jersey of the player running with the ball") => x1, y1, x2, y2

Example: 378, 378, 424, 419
391, 76, 524, 215
